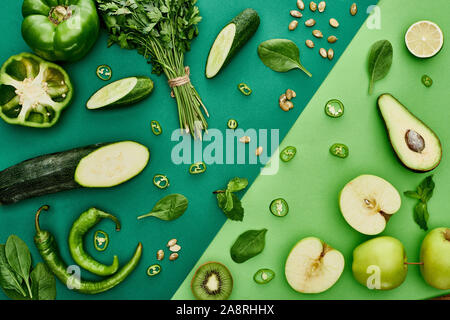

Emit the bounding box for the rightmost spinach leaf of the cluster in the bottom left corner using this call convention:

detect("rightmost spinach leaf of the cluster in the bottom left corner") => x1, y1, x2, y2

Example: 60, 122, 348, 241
30, 262, 56, 300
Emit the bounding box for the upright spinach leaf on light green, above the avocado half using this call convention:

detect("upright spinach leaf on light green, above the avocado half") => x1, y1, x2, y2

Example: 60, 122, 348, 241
369, 40, 393, 94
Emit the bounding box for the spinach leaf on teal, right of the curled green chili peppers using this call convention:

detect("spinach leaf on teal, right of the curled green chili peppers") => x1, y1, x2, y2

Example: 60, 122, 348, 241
138, 194, 188, 221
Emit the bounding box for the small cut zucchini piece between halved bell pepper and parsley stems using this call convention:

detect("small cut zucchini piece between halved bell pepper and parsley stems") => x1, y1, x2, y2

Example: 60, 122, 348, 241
86, 77, 153, 110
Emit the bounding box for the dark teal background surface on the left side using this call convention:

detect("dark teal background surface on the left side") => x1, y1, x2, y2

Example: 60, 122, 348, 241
0, 0, 376, 299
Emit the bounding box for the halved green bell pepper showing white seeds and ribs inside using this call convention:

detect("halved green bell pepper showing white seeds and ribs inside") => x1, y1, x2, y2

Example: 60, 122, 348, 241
0, 53, 73, 128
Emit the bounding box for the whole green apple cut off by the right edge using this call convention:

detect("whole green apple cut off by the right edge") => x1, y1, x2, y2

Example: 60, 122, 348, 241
420, 228, 450, 290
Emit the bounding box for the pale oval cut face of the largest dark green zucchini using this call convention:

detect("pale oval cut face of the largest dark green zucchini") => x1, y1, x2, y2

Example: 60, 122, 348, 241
75, 141, 150, 188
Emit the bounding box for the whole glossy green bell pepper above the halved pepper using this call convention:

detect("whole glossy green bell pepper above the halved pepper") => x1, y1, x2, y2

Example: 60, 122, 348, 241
22, 0, 100, 61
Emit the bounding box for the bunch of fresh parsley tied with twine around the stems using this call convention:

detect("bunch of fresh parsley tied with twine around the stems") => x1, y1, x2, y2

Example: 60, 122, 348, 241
96, 0, 208, 139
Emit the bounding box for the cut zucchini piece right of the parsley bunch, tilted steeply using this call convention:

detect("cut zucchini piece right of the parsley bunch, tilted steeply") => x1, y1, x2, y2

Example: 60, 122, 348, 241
205, 9, 259, 79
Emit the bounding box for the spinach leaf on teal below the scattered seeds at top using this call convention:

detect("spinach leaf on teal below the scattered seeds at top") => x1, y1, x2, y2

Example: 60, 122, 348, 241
258, 39, 312, 77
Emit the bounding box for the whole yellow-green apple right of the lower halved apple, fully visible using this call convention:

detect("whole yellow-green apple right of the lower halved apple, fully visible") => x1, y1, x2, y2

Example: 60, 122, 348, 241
352, 237, 408, 290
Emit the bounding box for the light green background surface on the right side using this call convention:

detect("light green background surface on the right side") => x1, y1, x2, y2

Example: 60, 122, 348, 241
174, 0, 450, 299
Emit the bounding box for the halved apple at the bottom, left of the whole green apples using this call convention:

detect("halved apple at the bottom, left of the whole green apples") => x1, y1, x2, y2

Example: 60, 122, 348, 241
285, 237, 345, 293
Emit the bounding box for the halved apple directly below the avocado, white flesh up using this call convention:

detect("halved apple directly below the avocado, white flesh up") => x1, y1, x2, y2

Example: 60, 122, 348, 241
339, 174, 402, 235
